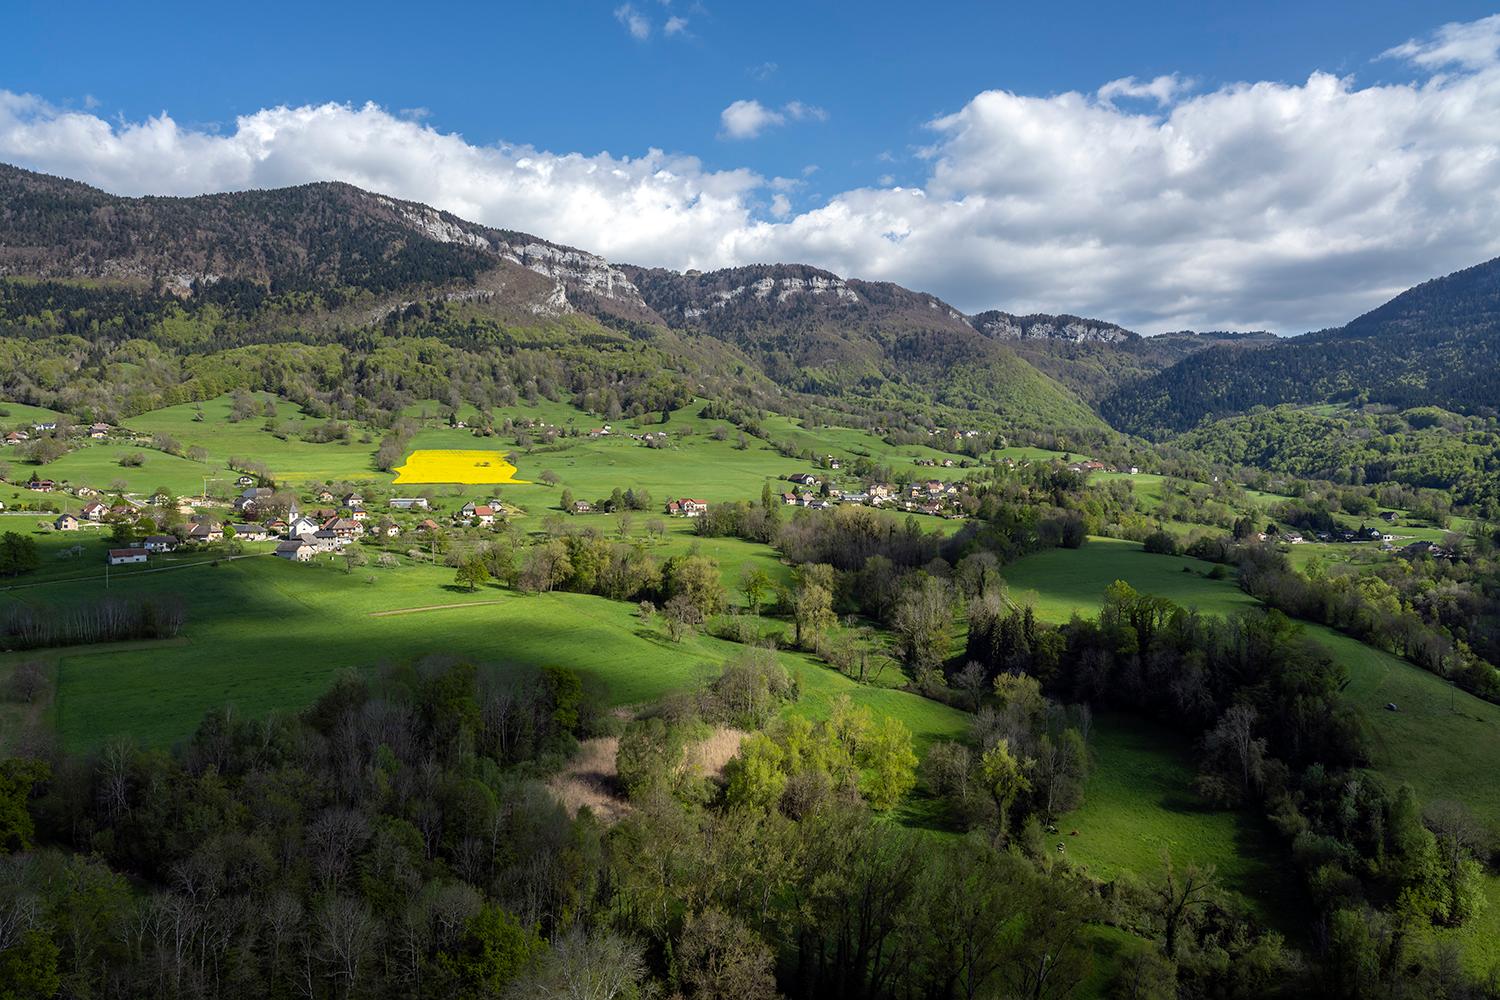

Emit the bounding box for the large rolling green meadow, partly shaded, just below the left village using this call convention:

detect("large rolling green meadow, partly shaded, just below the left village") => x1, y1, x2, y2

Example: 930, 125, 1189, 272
0, 542, 962, 750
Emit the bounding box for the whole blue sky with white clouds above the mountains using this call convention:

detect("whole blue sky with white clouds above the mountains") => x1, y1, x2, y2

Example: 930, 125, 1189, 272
0, 0, 1500, 334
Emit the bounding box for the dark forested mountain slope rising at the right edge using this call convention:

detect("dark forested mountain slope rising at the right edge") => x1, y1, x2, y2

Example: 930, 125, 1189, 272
1100, 258, 1500, 438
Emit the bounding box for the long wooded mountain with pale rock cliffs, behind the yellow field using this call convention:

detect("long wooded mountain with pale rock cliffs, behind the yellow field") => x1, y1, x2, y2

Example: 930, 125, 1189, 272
0, 165, 1103, 430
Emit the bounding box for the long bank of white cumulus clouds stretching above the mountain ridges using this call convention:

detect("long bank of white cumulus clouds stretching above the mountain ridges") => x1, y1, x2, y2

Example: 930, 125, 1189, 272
0, 13, 1500, 333
